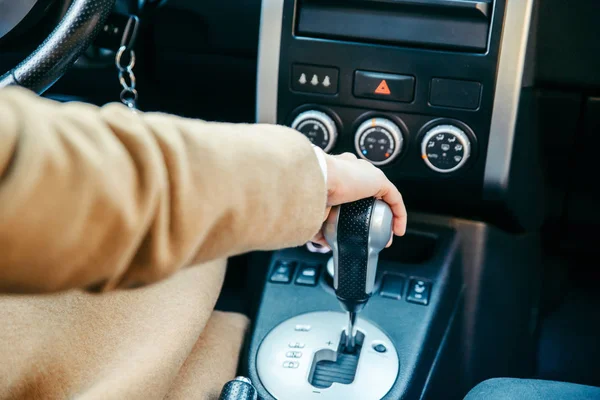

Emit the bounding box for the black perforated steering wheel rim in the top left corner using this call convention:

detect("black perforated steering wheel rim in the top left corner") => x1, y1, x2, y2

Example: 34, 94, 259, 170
0, 0, 115, 94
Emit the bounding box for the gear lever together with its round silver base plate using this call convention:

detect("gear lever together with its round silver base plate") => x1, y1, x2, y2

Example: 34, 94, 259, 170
256, 198, 399, 400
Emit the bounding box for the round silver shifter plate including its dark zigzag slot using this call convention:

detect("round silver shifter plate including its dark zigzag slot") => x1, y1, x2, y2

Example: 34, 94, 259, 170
256, 311, 399, 400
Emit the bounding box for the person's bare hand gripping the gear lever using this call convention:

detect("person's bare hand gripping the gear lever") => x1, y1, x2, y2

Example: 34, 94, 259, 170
312, 153, 407, 247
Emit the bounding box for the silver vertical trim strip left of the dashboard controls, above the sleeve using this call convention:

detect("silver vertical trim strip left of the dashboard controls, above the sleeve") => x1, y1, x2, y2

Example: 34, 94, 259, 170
256, 0, 284, 124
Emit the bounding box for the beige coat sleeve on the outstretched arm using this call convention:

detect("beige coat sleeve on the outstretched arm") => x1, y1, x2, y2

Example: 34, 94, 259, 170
0, 88, 326, 292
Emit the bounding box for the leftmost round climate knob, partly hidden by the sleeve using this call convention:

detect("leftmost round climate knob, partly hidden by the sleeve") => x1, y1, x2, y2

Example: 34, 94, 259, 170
292, 110, 337, 152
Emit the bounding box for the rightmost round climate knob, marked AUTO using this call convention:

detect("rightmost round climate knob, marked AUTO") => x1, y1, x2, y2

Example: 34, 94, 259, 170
421, 124, 471, 173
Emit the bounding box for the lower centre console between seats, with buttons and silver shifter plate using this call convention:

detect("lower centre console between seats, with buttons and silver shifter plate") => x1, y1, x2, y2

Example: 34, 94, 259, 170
244, 214, 539, 400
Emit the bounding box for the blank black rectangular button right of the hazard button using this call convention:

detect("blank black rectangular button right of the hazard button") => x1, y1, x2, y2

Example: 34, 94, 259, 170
429, 78, 481, 110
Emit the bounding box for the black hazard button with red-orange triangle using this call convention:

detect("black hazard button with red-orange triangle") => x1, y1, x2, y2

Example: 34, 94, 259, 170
354, 71, 415, 103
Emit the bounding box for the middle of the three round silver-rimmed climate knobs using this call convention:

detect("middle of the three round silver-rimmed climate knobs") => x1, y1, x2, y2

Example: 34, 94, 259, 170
354, 118, 404, 165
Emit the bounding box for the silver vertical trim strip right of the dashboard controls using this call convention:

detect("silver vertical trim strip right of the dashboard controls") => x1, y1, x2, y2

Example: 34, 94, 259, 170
484, 0, 534, 189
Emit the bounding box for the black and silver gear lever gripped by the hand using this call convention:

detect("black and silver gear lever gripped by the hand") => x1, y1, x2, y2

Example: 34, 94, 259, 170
324, 197, 393, 352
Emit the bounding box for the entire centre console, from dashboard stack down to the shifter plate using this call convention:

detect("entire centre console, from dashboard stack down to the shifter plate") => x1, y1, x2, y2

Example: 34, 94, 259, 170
246, 0, 539, 400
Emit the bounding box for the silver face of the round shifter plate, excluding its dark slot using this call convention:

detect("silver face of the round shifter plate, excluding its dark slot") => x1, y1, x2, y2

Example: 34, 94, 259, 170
256, 311, 400, 400
